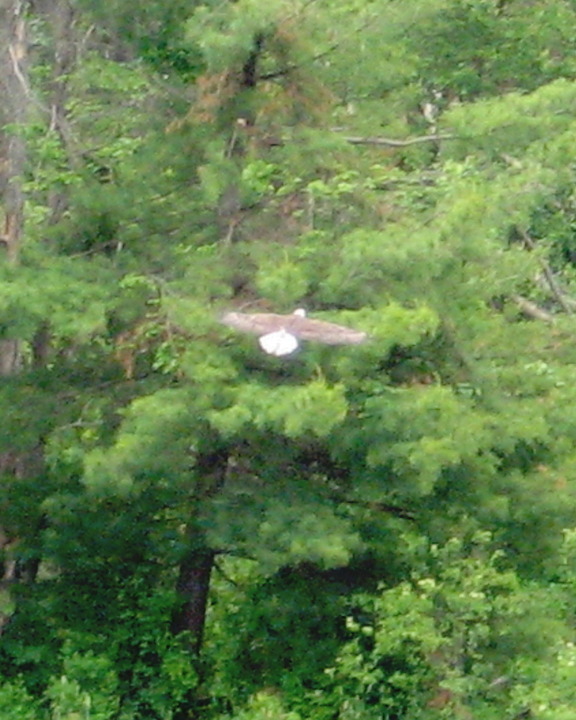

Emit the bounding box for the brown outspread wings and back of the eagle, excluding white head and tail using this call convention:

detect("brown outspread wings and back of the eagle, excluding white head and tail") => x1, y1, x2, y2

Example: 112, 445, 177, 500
222, 312, 367, 345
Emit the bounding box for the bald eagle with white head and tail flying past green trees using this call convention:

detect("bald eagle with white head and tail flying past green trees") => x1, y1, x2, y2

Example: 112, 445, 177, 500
221, 308, 368, 357
